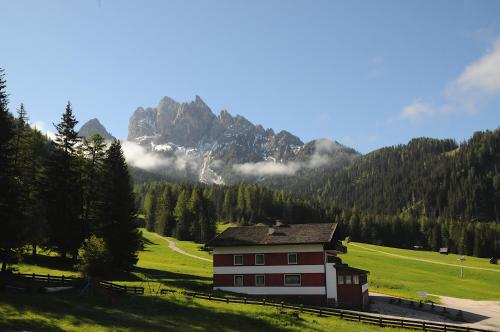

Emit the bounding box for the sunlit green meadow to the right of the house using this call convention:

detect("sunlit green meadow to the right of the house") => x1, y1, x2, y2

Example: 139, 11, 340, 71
341, 243, 500, 300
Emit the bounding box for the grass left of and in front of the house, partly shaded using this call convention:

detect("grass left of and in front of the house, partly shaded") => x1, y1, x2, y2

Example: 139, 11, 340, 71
0, 232, 406, 332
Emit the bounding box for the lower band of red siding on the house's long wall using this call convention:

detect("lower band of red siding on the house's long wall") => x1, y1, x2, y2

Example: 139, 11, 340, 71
214, 273, 325, 287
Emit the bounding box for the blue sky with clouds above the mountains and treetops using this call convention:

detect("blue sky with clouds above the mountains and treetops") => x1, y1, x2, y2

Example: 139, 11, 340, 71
0, 0, 500, 153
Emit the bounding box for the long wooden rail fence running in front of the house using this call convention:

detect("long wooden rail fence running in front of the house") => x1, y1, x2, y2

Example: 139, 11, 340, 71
180, 292, 489, 332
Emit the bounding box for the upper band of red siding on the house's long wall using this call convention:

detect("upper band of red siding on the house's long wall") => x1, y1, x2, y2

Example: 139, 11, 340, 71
213, 252, 324, 266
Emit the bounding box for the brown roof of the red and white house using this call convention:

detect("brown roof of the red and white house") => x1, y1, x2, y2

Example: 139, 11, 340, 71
207, 223, 337, 247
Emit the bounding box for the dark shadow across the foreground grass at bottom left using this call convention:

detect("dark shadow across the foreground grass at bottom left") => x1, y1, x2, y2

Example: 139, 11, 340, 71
0, 291, 292, 331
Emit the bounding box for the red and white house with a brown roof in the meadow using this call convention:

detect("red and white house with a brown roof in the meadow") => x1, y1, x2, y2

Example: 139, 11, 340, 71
207, 223, 368, 309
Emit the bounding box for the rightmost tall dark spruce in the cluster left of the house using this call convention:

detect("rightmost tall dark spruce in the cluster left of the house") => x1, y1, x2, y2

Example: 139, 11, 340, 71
100, 140, 141, 271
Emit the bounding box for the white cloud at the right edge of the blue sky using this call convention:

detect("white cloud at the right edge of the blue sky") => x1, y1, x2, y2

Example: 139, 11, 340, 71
399, 39, 500, 120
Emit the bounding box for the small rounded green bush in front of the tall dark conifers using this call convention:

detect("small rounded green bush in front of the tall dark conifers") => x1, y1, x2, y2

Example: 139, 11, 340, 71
78, 235, 111, 277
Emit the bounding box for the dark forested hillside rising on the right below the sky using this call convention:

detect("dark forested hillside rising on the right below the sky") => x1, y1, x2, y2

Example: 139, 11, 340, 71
292, 129, 500, 222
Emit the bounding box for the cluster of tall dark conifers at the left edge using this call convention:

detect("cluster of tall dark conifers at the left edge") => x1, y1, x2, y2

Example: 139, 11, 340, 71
0, 70, 141, 273
